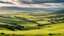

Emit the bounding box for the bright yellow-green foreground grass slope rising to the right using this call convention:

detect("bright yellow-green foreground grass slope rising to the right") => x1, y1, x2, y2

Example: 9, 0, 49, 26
0, 23, 64, 35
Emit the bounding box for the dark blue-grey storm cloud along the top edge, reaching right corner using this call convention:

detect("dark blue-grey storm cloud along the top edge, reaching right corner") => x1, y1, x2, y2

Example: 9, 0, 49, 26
20, 0, 64, 4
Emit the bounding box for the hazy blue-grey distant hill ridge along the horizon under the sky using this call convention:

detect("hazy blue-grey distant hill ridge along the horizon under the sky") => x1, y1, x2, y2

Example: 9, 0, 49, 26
0, 7, 64, 11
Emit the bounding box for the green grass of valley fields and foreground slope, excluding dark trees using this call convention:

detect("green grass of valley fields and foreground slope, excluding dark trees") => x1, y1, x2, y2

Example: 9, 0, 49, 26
0, 11, 64, 36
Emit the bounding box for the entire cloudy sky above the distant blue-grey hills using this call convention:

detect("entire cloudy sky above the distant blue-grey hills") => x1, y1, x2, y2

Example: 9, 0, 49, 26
0, 0, 64, 8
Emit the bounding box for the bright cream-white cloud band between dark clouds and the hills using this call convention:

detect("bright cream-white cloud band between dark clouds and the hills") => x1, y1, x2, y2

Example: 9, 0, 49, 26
0, 0, 64, 8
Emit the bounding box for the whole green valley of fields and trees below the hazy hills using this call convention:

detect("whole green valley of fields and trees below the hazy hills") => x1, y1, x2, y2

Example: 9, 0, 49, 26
0, 12, 64, 36
